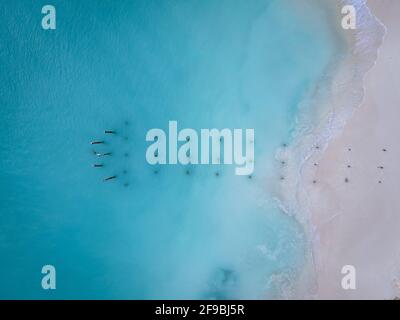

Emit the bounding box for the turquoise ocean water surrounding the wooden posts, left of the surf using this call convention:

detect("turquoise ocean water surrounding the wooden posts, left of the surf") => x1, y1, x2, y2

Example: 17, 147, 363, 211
0, 0, 339, 299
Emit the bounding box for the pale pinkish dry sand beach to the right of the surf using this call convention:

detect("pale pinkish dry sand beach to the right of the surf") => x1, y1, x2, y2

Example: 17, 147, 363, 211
307, 0, 400, 299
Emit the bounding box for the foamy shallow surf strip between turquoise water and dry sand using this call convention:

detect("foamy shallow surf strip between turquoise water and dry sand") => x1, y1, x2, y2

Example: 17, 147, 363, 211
276, 0, 386, 299
